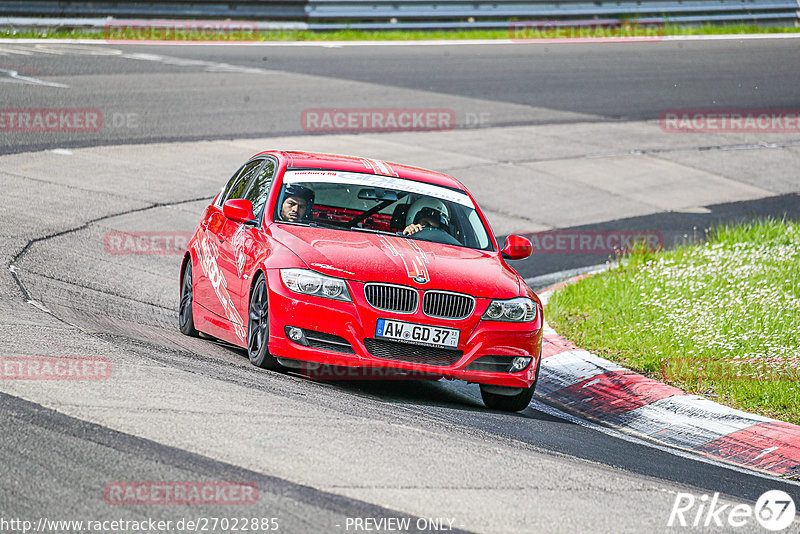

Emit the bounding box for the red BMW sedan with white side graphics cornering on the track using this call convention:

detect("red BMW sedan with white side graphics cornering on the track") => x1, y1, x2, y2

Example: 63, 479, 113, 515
179, 151, 543, 411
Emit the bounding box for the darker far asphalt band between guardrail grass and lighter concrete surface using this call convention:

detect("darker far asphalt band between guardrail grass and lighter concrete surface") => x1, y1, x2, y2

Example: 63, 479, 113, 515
0, 39, 800, 151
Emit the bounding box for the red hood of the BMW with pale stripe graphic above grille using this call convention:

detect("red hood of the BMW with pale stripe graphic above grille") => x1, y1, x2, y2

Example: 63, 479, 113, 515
271, 224, 520, 298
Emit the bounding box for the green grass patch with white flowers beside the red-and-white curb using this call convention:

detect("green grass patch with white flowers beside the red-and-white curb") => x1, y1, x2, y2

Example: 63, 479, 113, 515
545, 219, 800, 424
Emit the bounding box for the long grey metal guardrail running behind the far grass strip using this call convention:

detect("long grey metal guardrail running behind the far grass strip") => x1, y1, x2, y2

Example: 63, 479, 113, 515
0, 0, 800, 30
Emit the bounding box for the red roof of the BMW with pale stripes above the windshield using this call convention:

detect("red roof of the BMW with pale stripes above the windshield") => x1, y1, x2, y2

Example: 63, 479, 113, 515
252, 151, 465, 190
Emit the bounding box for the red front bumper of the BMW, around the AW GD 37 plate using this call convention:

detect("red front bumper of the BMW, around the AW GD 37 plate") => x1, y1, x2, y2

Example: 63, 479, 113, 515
267, 269, 542, 387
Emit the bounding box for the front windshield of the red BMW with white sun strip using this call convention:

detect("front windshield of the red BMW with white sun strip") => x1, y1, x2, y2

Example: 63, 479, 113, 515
274, 169, 492, 250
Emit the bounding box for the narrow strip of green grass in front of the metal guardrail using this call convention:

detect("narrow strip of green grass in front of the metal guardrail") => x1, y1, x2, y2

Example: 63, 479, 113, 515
0, 23, 800, 41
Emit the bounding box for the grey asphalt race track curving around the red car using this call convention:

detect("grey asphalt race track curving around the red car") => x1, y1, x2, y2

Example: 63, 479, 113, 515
0, 39, 800, 533
